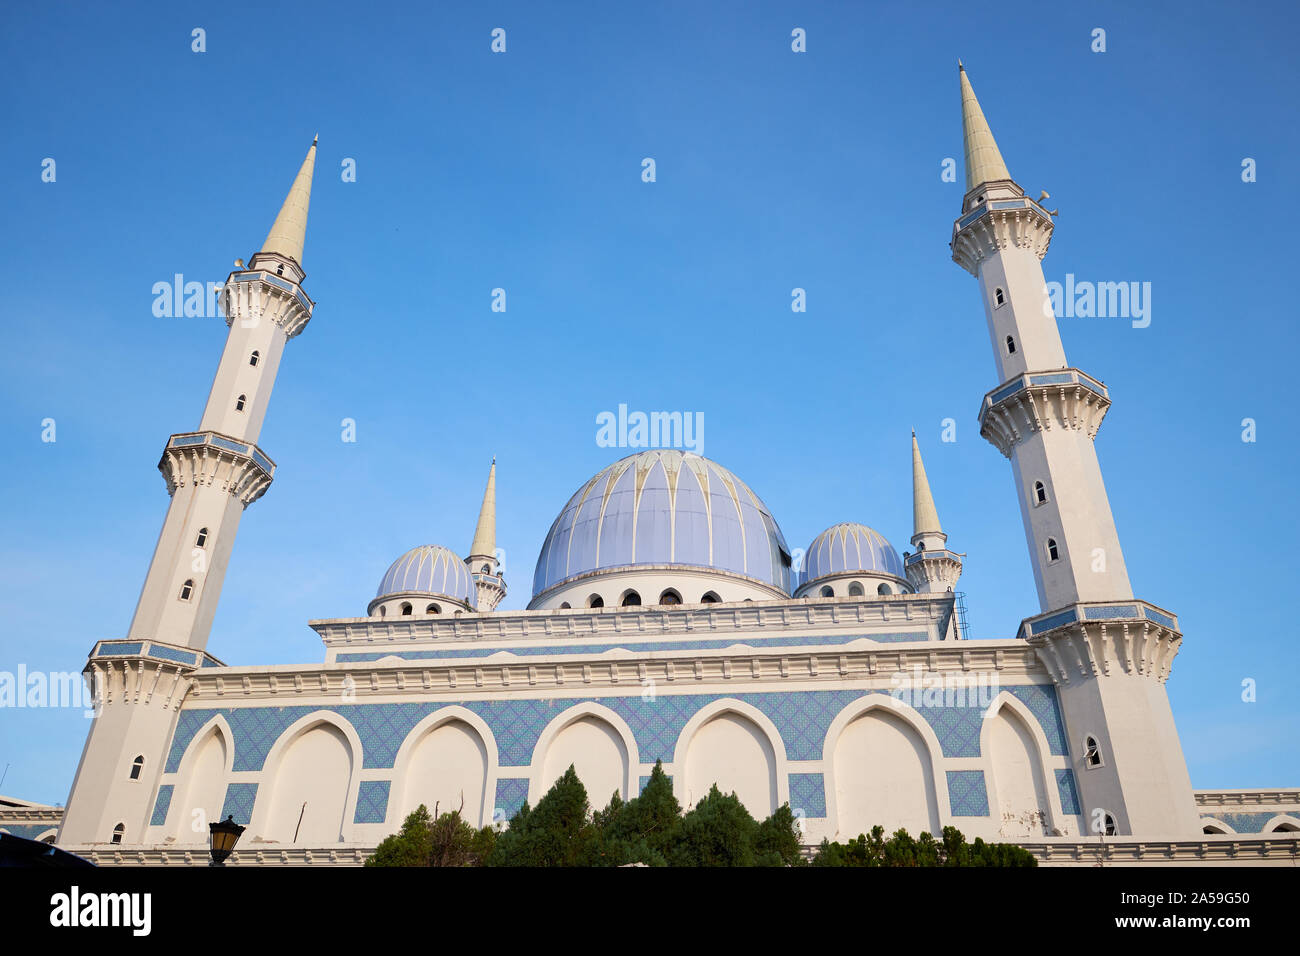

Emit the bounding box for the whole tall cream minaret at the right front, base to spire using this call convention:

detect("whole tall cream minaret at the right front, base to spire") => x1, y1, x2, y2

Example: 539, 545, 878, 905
952, 64, 1200, 839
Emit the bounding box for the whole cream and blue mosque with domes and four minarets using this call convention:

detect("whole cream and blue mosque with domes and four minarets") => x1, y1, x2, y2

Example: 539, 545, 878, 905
12, 63, 1300, 865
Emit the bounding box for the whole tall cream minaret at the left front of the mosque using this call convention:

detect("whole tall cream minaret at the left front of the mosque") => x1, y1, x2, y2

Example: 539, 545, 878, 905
59, 140, 316, 845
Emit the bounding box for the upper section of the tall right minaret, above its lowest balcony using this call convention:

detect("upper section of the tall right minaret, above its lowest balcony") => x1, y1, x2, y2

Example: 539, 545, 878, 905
952, 69, 1132, 610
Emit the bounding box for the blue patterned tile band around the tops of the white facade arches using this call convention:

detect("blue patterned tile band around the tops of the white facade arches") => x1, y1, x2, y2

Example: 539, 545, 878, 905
166, 684, 1066, 773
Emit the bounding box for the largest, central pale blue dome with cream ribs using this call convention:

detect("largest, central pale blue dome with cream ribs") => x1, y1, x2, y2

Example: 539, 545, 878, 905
533, 449, 790, 597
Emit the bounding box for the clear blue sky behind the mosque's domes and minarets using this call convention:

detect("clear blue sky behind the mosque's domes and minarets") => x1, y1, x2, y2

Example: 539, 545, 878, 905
0, 3, 1300, 803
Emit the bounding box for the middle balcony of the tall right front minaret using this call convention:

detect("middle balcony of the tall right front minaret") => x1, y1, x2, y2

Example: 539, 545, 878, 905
979, 368, 1110, 458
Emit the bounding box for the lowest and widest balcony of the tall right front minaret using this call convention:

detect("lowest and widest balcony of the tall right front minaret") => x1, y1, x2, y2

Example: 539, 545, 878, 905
1017, 601, 1183, 684
